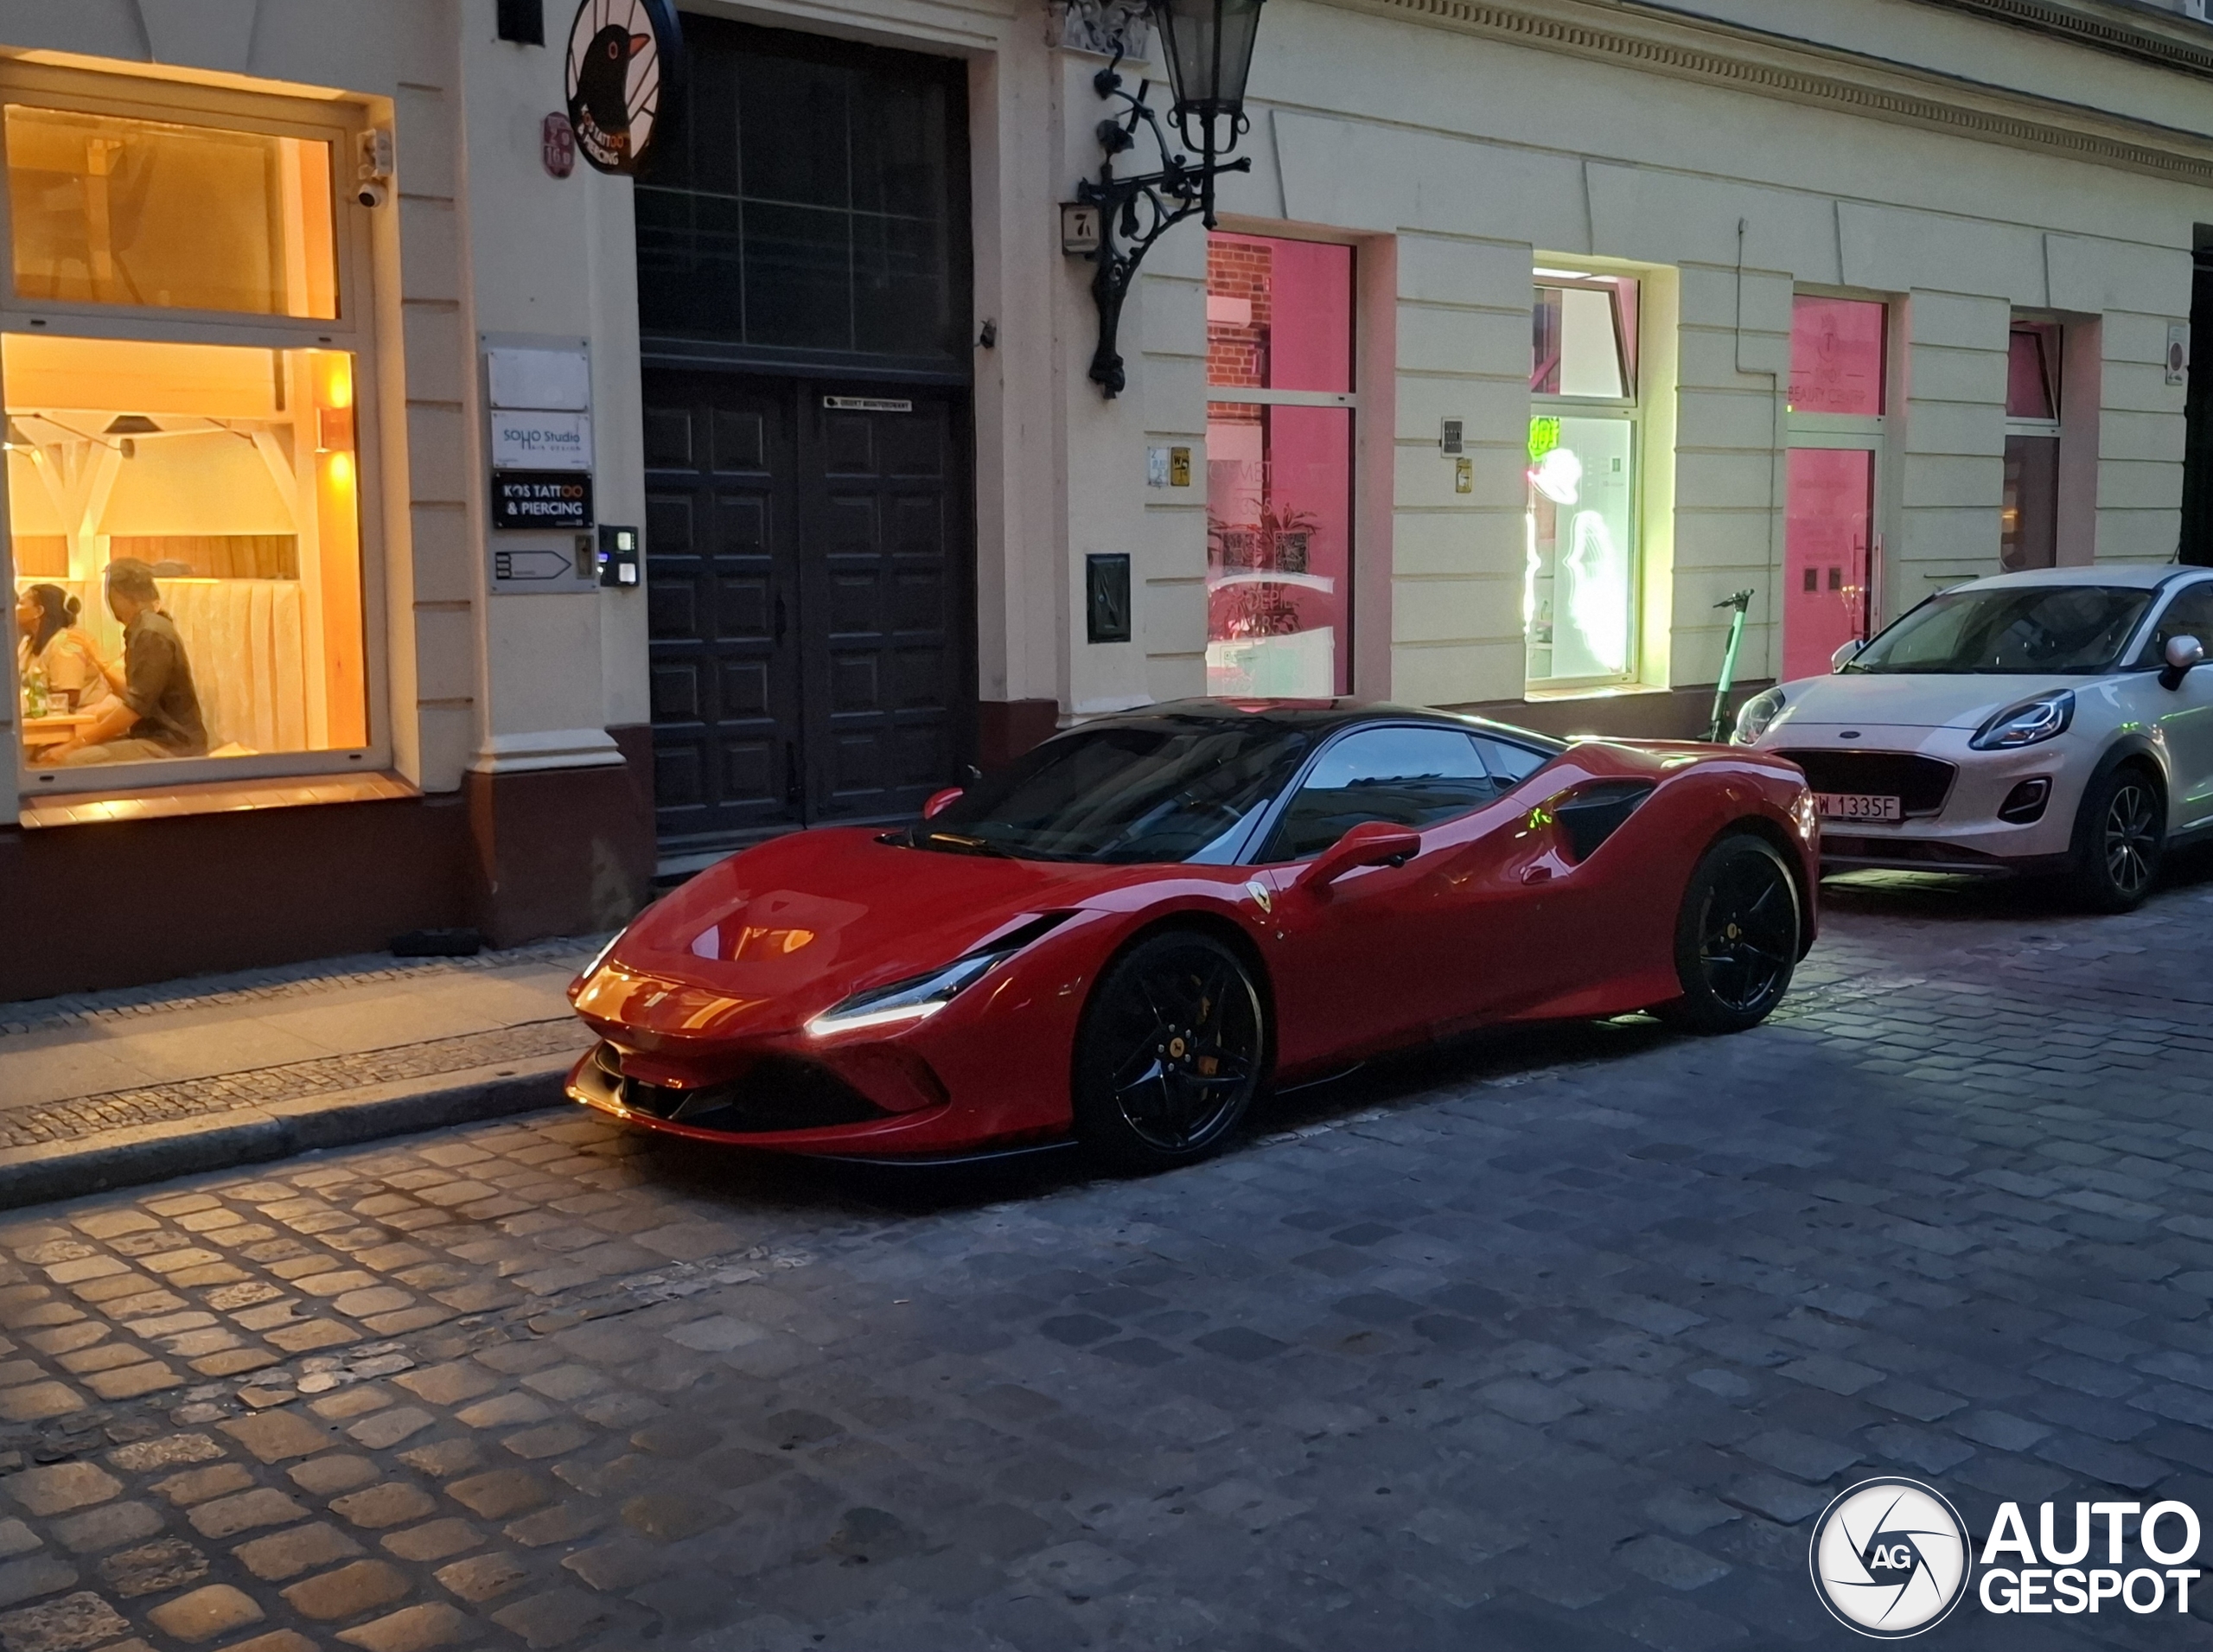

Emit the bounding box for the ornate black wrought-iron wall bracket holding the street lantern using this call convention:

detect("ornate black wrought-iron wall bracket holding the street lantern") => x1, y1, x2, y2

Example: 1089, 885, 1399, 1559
1075, 51, 1253, 399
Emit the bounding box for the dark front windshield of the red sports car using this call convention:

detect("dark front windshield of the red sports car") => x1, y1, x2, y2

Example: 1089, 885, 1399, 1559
905, 720, 1312, 861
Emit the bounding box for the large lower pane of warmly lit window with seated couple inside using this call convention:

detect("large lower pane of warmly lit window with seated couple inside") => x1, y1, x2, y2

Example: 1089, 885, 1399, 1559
0, 335, 367, 769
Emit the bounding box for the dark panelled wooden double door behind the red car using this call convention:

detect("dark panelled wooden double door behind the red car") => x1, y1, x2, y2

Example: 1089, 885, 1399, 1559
644, 370, 973, 857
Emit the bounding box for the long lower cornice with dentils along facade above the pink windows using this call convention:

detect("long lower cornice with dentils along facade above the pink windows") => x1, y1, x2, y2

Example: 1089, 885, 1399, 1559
1323, 0, 2213, 186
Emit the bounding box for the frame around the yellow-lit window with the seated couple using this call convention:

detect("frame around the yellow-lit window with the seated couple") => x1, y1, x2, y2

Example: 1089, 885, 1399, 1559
0, 62, 392, 806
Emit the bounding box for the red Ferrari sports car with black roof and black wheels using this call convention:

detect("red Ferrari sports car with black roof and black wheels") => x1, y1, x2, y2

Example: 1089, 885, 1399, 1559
569, 699, 1819, 1170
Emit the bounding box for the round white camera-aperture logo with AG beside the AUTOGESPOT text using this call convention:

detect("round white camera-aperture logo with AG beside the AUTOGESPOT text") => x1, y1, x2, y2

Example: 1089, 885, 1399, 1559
1810, 1479, 1969, 1641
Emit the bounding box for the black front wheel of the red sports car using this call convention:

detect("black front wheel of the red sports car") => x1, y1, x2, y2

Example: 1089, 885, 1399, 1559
1071, 930, 1268, 1171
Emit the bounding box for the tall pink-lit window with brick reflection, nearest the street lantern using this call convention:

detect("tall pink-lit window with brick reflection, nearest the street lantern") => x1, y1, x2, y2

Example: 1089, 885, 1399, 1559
1206, 235, 1355, 698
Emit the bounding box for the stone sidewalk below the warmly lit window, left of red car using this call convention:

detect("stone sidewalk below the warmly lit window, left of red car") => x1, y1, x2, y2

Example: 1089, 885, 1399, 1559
0, 939, 600, 1158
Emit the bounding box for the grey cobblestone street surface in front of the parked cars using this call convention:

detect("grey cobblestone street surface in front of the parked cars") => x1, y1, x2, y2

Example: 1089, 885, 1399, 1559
0, 879, 2213, 1652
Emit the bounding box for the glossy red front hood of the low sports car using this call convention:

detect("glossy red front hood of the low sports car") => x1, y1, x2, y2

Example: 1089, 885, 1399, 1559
571, 828, 1138, 1041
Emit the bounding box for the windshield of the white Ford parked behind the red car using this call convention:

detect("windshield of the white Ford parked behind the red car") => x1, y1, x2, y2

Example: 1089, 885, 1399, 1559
1843, 584, 2151, 673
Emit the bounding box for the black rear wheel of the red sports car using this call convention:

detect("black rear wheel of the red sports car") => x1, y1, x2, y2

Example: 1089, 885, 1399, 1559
1655, 832, 1806, 1034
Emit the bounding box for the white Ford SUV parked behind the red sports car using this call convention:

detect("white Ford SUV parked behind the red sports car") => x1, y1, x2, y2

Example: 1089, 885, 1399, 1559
1735, 567, 2213, 912
